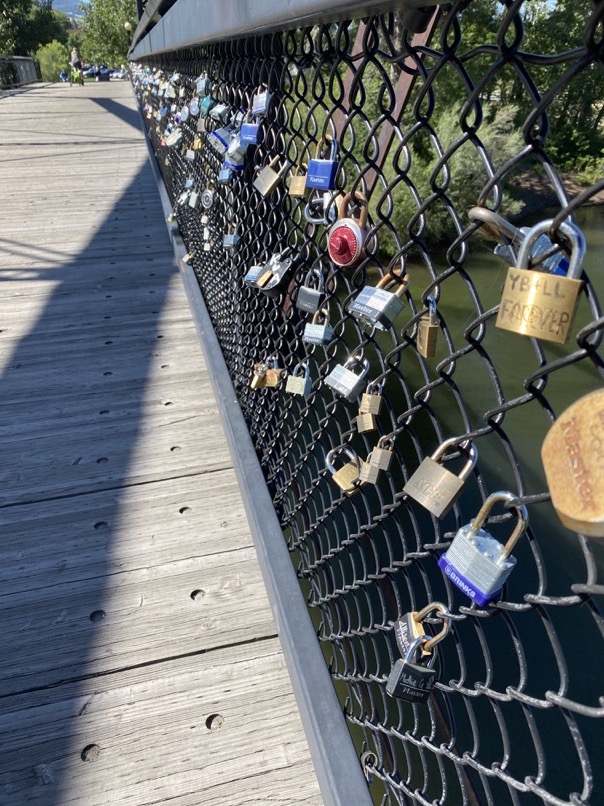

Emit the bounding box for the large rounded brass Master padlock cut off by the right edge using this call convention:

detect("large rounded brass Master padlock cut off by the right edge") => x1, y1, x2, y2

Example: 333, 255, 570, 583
541, 389, 604, 537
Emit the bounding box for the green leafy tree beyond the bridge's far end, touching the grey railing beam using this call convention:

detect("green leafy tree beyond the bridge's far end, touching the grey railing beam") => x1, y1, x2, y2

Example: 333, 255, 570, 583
80, 0, 137, 65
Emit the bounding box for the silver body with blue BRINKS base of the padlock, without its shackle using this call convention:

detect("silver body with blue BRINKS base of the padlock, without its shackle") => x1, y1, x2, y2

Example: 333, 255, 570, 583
438, 524, 516, 606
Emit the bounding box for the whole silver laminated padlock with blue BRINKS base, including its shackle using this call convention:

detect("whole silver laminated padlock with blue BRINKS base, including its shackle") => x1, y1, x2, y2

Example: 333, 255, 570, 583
438, 492, 528, 606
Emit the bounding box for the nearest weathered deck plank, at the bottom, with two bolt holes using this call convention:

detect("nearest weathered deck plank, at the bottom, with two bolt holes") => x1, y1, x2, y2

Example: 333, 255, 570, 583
0, 641, 321, 806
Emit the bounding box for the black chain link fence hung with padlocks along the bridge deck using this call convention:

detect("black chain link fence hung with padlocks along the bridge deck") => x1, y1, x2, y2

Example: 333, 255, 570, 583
134, 0, 604, 806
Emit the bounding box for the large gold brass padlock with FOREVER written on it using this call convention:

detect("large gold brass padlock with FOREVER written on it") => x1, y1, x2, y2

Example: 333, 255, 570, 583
495, 219, 585, 344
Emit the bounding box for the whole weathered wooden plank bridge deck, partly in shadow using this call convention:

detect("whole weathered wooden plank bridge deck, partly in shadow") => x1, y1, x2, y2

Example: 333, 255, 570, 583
0, 82, 321, 806
